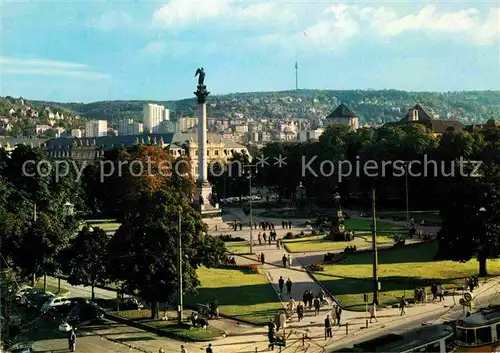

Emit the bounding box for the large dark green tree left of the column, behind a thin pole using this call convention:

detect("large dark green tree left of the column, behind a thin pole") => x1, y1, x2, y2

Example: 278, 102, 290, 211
108, 190, 225, 318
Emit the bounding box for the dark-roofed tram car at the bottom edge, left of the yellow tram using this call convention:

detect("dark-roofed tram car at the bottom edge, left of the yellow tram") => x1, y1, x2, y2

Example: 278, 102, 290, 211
336, 324, 455, 353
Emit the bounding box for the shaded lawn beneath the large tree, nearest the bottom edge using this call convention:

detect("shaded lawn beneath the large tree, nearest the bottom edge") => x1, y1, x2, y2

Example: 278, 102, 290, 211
113, 309, 225, 342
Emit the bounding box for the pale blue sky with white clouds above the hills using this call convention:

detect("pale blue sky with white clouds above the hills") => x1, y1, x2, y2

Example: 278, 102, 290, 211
0, 0, 500, 102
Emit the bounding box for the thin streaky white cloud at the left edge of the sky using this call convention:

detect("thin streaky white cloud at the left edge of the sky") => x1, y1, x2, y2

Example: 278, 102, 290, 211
0, 57, 109, 80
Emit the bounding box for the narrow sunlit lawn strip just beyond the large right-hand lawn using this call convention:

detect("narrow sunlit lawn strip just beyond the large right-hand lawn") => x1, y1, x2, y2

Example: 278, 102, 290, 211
283, 234, 394, 253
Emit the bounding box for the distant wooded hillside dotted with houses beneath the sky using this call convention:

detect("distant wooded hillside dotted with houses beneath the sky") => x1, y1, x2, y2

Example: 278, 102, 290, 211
16, 90, 500, 124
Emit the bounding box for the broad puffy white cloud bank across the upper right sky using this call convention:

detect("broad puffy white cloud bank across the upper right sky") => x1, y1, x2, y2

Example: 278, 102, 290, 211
148, 0, 500, 52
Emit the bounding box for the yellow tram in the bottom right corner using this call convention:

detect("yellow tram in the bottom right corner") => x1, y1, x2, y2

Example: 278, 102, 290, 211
455, 305, 500, 352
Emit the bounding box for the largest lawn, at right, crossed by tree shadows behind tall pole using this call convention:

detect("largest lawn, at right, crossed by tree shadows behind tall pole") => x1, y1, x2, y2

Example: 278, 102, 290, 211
308, 242, 500, 310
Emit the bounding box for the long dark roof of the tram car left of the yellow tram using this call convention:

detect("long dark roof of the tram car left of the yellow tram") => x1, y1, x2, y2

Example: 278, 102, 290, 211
339, 324, 453, 352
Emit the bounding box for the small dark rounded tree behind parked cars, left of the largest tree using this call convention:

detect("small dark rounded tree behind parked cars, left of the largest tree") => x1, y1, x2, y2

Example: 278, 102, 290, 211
65, 227, 110, 300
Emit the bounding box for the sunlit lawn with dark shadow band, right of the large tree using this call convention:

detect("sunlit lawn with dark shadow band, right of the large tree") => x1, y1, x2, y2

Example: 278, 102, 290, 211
185, 267, 283, 324
